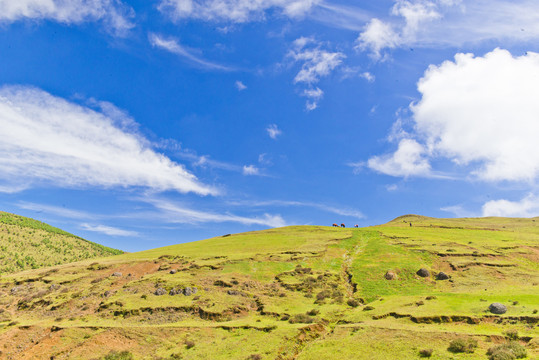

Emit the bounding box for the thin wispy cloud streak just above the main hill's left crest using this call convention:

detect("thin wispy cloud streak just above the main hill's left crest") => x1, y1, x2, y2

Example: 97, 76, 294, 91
143, 198, 286, 227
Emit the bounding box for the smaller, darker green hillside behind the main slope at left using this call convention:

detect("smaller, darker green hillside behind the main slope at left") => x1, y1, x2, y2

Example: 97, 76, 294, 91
0, 212, 122, 274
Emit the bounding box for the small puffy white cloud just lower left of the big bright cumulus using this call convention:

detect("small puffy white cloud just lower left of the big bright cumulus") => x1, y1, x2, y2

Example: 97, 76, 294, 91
367, 139, 430, 177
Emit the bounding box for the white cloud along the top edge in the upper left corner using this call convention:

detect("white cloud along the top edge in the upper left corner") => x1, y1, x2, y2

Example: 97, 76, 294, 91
0, 0, 134, 35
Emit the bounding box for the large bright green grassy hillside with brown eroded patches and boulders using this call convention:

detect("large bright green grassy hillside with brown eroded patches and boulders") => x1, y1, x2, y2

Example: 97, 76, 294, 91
0, 215, 539, 360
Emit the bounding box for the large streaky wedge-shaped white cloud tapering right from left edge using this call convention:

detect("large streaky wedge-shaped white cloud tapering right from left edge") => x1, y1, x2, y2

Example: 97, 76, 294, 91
0, 86, 216, 195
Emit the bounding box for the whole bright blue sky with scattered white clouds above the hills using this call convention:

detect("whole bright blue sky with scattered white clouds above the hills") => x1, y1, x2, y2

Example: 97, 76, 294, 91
0, 0, 539, 251
